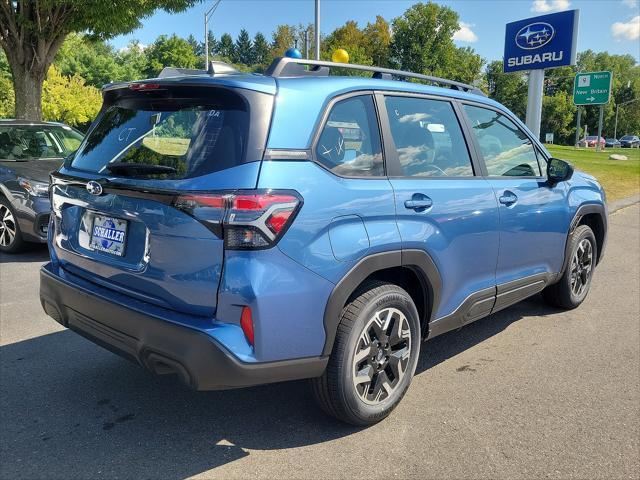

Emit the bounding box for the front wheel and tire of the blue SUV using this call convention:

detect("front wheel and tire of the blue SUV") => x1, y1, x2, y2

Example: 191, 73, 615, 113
542, 225, 598, 309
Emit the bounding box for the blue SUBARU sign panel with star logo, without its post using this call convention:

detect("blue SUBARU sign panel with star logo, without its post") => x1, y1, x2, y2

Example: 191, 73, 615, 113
504, 10, 578, 72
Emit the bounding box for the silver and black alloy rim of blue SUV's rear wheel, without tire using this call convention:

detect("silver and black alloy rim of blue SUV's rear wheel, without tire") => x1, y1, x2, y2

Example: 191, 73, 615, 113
352, 308, 412, 405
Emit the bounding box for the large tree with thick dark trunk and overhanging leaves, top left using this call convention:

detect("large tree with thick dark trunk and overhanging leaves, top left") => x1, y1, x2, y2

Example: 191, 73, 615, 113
0, 0, 199, 120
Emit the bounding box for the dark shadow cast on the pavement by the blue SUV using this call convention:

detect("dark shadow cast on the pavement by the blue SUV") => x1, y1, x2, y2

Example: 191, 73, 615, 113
0, 301, 552, 479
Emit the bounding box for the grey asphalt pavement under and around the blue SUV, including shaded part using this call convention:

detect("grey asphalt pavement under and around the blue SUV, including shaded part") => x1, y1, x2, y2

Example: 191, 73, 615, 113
0, 205, 640, 479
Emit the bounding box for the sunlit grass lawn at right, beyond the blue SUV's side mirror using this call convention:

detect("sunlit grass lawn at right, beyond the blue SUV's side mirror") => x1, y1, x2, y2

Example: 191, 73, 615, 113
546, 145, 640, 201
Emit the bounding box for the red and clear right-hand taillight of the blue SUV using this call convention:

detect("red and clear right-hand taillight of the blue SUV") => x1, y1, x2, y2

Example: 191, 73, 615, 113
173, 191, 302, 250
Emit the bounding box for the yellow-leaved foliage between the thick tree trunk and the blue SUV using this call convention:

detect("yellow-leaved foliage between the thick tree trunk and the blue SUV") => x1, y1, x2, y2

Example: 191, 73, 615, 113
42, 66, 102, 126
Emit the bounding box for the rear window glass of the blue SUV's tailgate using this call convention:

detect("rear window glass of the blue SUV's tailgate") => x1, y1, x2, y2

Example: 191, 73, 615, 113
71, 89, 266, 179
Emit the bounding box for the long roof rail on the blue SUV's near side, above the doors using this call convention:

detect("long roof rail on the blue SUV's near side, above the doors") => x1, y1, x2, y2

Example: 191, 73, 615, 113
265, 57, 486, 96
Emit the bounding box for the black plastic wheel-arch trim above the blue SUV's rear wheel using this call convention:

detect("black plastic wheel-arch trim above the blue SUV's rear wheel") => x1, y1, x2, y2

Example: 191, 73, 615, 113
322, 250, 442, 355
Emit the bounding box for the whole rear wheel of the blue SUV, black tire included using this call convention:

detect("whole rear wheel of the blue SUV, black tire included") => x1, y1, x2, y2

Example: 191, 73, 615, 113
311, 282, 421, 426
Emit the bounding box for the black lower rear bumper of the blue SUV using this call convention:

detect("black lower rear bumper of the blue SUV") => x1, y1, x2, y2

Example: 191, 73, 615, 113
40, 263, 328, 390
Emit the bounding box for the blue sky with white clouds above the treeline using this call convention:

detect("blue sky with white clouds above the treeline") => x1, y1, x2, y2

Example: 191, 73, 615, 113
111, 0, 640, 62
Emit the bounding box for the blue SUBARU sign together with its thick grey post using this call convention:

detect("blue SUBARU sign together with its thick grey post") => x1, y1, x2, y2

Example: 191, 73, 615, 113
503, 10, 579, 138
